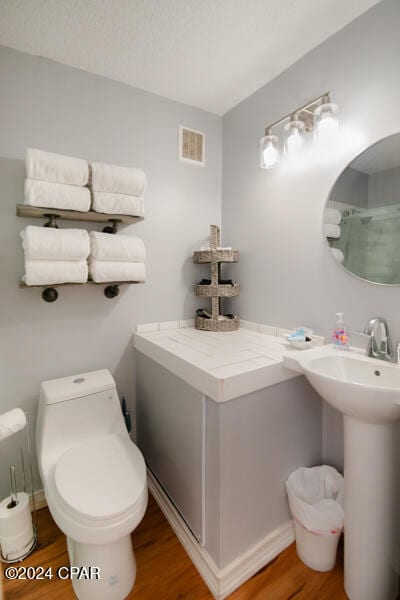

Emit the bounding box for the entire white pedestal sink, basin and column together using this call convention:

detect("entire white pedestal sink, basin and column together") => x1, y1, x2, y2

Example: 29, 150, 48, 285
284, 346, 400, 600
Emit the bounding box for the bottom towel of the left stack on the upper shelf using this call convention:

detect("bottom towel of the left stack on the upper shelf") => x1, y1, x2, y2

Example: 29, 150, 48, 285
25, 179, 90, 212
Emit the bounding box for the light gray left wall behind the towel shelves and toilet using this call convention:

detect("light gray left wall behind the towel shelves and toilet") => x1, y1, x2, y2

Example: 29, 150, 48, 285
0, 48, 222, 497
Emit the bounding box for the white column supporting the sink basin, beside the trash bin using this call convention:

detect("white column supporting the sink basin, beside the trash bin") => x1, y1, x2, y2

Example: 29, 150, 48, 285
343, 415, 398, 600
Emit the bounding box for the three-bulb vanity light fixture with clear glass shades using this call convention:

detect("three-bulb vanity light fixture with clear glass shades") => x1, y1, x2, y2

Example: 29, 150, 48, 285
260, 92, 339, 169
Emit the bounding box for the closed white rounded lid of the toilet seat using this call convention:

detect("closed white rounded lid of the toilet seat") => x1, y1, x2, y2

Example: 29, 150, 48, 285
54, 435, 146, 519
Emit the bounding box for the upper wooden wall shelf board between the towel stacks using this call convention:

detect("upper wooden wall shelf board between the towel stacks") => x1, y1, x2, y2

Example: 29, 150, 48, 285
17, 204, 143, 225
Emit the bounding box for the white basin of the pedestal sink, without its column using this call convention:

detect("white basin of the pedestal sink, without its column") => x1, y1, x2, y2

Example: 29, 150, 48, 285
298, 349, 400, 423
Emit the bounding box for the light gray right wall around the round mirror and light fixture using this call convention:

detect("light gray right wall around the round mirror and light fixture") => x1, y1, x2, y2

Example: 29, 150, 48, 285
223, 0, 400, 464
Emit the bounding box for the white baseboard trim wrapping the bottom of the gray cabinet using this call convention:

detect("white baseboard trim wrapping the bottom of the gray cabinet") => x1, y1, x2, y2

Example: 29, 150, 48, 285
147, 470, 295, 600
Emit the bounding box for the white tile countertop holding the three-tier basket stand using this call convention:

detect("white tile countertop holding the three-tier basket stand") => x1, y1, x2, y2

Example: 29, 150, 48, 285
133, 320, 324, 402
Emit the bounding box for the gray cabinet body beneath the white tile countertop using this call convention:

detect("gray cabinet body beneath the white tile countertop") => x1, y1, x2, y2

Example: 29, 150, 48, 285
135, 334, 322, 572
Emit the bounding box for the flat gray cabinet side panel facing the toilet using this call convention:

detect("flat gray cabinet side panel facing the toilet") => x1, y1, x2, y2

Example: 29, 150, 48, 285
136, 352, 205, 541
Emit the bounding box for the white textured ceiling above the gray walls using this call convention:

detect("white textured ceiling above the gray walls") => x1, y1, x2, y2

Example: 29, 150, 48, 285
0, 0, 378, 114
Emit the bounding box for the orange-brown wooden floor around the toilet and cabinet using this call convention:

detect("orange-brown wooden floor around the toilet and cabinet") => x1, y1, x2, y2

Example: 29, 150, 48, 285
3, 498, 347, 600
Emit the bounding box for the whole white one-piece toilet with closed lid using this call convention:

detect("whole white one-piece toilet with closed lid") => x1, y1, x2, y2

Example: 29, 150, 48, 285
36, 370, 147, 600
